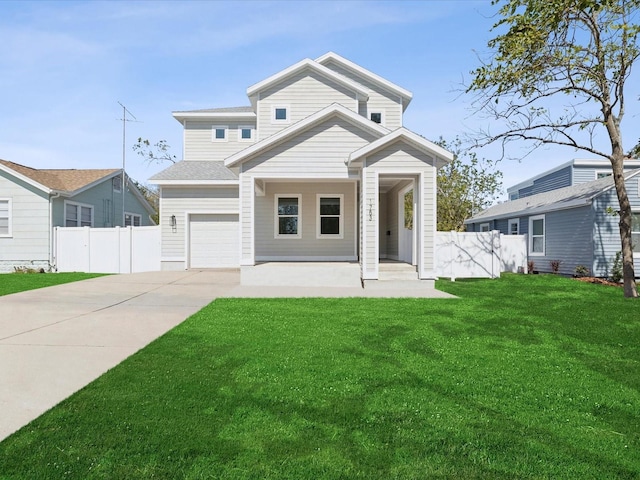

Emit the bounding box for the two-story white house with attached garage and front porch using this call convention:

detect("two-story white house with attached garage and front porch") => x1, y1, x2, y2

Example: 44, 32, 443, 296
150, 53, 453, 283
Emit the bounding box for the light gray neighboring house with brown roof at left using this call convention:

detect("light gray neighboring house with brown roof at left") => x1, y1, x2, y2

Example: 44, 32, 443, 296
0, 160, 154, 271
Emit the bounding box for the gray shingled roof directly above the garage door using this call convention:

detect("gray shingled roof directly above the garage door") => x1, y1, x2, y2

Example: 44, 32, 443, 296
149, 160, 238, 185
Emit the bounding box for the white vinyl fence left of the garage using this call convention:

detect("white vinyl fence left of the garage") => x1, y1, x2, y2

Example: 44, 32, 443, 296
54, 226, 160, 273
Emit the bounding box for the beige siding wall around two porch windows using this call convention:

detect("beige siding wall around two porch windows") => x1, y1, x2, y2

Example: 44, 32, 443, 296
255, 182, 357, 261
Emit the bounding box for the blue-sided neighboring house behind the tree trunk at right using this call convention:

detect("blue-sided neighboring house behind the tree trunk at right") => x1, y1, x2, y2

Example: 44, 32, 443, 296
465, 160, 640, 277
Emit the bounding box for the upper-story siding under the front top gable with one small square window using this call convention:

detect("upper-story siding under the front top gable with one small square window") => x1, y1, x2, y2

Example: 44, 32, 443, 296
257, 71, 358, 140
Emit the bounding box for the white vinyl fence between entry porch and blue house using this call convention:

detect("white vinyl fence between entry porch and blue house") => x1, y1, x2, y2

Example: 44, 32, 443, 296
436, 230, 527, 280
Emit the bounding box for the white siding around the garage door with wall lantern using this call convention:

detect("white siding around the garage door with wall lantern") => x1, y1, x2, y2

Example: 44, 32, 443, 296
160, 187, 239, 270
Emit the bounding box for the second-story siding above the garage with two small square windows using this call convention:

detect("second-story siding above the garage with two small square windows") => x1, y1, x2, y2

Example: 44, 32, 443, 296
184, 118, 256, 161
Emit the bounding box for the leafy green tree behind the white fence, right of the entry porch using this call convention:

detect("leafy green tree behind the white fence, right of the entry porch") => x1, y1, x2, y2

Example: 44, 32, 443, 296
437, 138, 502, 232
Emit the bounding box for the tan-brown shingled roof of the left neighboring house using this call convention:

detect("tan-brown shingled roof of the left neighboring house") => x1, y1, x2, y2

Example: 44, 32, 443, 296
0, 160, 122, 194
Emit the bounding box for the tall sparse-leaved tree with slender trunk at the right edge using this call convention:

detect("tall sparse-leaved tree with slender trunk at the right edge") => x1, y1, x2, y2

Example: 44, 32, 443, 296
467, 0, 640, 297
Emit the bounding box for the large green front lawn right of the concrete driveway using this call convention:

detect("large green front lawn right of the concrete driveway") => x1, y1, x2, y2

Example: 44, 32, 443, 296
0, 275, 640, 480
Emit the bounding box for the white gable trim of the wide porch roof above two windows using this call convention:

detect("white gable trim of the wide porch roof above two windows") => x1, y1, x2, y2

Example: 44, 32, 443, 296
224, 103, 389, 167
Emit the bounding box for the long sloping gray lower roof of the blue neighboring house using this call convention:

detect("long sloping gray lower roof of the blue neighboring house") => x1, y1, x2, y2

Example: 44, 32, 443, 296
464, 169, 640, 224
